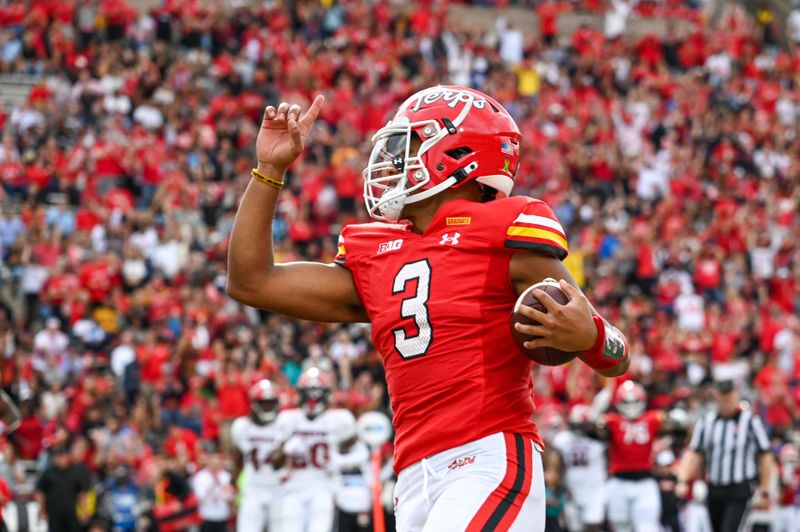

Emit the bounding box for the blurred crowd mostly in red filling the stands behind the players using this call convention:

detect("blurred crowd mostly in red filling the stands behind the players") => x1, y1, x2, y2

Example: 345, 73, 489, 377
0, 0, 800, 530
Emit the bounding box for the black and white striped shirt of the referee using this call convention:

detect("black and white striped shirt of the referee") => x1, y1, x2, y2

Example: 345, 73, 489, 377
689, 410, 770, 486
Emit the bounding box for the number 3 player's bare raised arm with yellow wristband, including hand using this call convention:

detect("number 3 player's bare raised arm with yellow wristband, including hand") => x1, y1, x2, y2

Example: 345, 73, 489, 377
227, 96, 368, 322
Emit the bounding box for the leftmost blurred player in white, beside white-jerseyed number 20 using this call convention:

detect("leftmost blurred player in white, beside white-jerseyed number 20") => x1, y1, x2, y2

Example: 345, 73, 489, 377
231, 379, 289, 532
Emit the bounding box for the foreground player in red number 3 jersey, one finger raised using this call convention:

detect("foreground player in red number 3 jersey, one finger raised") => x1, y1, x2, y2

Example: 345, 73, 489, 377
228, 86, 629, 532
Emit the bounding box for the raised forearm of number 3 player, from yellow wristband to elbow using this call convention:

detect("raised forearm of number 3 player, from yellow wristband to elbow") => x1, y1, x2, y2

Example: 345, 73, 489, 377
228, 166, 283, 300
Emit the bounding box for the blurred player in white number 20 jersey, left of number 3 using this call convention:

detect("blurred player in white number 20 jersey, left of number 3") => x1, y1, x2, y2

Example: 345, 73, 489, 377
277, 368, 356, 532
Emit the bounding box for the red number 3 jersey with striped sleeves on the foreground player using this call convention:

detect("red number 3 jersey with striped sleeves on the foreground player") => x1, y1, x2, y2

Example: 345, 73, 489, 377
336, 196, 567, 471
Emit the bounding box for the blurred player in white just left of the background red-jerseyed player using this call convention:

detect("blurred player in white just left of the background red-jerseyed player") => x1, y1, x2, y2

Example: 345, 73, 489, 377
553, 405, 607, 532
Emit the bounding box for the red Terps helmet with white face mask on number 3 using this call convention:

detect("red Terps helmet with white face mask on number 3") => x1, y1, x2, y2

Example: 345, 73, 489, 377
364, 86, 521, 222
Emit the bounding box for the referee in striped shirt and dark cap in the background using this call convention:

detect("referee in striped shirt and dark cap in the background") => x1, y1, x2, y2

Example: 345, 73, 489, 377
675, 380, 775, 532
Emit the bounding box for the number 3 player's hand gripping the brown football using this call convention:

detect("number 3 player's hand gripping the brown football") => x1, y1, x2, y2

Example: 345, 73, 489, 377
515, 279, 597, 353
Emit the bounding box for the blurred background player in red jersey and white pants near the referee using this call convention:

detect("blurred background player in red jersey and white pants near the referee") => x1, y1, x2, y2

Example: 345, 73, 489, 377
603, 381, 664, 532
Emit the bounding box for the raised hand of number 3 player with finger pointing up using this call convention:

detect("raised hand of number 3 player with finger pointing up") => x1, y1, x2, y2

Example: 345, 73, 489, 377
256, 94, 325, 179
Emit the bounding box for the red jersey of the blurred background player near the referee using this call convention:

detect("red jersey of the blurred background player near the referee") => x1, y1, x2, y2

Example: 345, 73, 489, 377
606, 410, 663, 475
